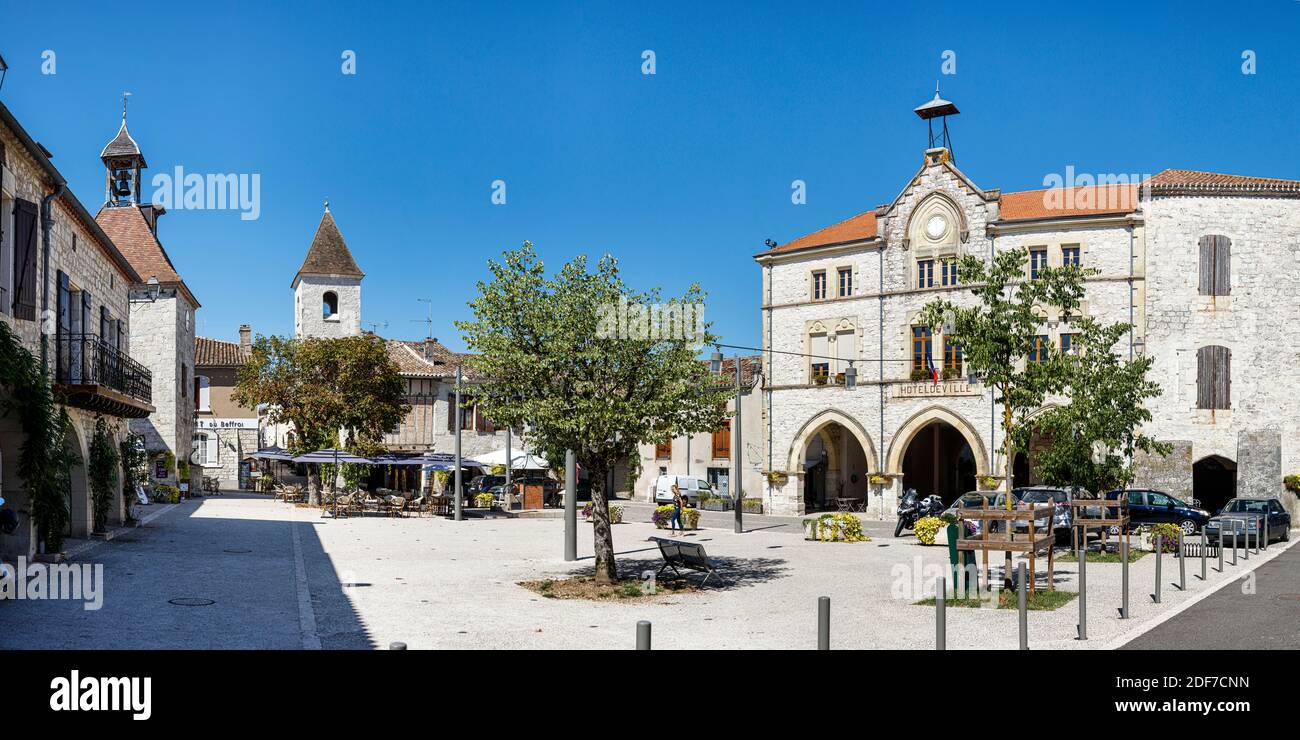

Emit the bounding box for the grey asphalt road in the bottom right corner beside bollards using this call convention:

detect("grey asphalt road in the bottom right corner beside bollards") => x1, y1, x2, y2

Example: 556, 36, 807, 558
1122, 532, 1300, 650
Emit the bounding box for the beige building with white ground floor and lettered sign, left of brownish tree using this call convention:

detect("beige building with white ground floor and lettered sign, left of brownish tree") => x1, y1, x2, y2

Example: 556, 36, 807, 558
194, 324, 263, 490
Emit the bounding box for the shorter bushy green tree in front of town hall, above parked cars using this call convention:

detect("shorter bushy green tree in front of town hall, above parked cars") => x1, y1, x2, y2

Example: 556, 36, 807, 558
1019, 319, 1171, 494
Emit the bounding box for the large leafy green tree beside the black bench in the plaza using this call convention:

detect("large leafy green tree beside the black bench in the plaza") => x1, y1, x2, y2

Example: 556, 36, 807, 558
456, 242, 729, 583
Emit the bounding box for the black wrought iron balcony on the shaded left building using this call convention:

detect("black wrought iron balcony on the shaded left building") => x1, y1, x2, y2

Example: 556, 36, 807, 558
55, 334, 153, 419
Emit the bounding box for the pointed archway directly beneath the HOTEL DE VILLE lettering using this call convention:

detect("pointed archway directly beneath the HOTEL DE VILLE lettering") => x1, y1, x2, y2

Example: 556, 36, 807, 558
887, 406, 988, 503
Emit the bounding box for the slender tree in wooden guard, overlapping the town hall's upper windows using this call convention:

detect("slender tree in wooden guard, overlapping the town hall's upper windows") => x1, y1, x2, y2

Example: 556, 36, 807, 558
920, 248, 1097, 509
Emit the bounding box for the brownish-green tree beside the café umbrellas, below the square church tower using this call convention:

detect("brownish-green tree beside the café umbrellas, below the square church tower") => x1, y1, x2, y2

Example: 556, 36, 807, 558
231, 336, 411, 505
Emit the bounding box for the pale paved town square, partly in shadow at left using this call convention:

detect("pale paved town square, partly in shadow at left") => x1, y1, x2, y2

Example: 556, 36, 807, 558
0, 494, 1290, 649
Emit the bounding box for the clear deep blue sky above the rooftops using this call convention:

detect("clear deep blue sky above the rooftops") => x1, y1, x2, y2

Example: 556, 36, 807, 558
0, 0, 1300, 349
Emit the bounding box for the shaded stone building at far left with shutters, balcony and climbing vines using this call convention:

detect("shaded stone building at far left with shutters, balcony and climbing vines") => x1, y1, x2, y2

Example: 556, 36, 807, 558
0, 103, 153, 558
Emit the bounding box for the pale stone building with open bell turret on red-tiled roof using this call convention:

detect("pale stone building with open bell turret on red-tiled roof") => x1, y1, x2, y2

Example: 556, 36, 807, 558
95, 113, 202, 488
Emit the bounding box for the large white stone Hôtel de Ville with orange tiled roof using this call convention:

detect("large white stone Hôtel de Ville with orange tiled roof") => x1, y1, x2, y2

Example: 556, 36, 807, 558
755, 93, 1300, 518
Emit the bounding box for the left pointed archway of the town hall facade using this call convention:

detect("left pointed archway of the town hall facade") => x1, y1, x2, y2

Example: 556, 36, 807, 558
790, 411, 876, 511
